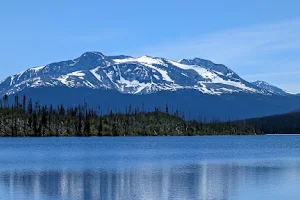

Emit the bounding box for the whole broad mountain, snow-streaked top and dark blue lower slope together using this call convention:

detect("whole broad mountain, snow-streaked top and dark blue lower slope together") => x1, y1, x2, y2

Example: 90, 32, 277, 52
0, 52, 300, 119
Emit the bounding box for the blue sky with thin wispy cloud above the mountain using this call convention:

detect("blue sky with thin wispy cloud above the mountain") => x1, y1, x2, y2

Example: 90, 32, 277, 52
0, 0, 300, 92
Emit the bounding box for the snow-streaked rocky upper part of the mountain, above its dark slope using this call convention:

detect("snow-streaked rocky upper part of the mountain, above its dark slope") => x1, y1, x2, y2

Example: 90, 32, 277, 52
0, 52, 270, 95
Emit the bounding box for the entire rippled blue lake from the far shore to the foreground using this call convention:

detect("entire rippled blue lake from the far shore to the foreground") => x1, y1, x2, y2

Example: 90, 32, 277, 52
0, 136, 300, 200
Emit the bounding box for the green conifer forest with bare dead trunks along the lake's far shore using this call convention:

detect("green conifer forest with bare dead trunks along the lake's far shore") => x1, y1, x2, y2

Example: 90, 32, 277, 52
0, 95, 263, 137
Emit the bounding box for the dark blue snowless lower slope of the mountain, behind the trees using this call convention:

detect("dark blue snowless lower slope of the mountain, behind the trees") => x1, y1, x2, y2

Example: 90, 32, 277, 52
10, 87, 300, 120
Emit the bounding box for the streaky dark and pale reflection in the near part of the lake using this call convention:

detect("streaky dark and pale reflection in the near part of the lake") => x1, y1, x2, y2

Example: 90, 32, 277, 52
0, 163, 300, 200
